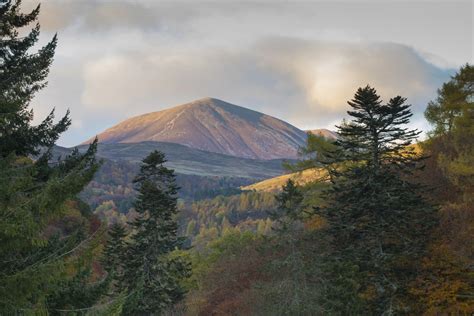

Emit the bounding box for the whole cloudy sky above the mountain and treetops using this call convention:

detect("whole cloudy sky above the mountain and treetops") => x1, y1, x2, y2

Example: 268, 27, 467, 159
23, 0, 474, 146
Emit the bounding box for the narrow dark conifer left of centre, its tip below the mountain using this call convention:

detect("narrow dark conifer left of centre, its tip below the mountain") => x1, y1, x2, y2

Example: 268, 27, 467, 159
124, 151, 190, 315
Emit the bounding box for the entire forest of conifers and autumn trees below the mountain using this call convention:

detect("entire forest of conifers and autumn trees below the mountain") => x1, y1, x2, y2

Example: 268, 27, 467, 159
0, 1, 474, 315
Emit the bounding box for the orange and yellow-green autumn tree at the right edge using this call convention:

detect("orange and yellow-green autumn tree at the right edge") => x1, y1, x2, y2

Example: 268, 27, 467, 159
413, 65, 474, 315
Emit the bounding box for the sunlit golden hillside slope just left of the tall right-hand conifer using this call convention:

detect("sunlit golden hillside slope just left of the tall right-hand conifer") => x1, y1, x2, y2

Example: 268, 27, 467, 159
241, 169, 327, 192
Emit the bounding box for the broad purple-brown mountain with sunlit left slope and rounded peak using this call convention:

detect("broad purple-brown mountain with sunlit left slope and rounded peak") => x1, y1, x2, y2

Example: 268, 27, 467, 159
86, 98, 306, 159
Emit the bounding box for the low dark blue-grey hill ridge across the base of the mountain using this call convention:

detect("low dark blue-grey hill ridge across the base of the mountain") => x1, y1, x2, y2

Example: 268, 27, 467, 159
54, 142, 283, 179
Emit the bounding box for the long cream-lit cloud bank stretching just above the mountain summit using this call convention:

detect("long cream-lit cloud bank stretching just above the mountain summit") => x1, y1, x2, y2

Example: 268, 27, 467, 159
82, 38, 450, 131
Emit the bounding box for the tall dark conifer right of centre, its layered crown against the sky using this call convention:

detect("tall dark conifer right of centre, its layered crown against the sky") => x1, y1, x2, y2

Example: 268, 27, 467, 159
315, 86, 435, 315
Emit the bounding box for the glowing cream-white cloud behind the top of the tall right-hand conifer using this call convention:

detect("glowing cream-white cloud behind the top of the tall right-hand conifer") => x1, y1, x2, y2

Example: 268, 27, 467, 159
254, 38, 449, 112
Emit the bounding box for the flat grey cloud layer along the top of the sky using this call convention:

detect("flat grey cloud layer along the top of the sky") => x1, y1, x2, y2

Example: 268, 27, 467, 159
30, 0, 473, 65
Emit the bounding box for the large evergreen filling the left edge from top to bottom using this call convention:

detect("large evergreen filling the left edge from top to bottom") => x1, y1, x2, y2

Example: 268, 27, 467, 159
0, 0, 100, 314
